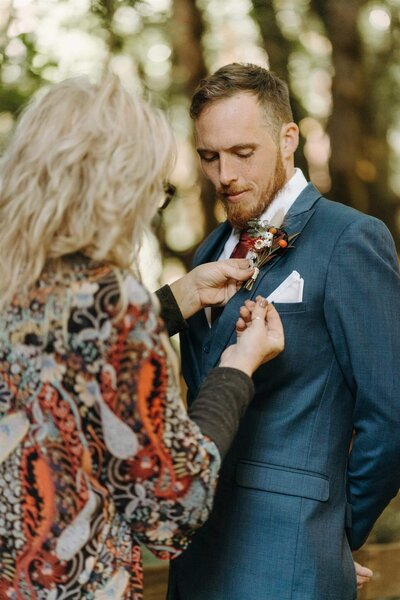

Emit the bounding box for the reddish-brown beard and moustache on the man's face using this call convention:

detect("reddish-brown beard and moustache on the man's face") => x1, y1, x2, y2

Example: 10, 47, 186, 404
219, 152, 286, 229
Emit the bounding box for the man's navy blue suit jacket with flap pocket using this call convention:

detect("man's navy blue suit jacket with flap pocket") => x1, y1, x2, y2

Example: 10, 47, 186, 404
169, 184, 400, 600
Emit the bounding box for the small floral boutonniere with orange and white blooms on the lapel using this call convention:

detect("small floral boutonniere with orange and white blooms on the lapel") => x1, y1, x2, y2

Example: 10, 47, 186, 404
244, 219, 299, 290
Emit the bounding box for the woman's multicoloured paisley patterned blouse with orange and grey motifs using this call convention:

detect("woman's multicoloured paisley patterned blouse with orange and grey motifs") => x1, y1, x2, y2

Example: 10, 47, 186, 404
0, 260, 220, 600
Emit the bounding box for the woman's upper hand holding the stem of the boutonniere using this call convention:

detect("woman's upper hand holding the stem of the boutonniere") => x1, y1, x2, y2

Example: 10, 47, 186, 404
170, 258, 254, 319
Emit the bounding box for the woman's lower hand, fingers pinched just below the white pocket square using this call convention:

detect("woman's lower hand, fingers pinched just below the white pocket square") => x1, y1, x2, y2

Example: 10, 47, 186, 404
220, 296, 285, 377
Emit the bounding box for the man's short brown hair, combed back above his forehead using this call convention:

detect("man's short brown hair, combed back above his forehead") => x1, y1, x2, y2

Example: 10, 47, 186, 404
190, 63, 293, 138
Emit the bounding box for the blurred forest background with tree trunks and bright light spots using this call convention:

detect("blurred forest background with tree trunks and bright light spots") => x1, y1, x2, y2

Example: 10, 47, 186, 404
0, 0, 400, 597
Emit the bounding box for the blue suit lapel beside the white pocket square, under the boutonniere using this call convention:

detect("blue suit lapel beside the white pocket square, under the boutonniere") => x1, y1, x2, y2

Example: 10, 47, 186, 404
206, 183, 321, 368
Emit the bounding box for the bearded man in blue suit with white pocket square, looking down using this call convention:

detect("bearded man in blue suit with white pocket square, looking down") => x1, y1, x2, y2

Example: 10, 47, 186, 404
168, 64, 400, 600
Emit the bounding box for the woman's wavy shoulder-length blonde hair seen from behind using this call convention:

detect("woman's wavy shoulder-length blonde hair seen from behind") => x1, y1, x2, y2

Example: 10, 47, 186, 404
0, 75, 175, 306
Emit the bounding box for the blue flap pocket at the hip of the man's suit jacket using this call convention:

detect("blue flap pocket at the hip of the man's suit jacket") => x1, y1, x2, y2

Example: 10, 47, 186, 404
236, 460, 329, 502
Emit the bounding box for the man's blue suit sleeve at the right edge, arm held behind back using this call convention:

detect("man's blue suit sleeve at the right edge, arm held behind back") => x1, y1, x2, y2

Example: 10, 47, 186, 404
324, 215, 400, 549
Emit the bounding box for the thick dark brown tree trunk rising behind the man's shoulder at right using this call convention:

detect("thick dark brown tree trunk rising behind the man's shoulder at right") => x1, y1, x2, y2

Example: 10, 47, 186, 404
313, 0, 397, 245
